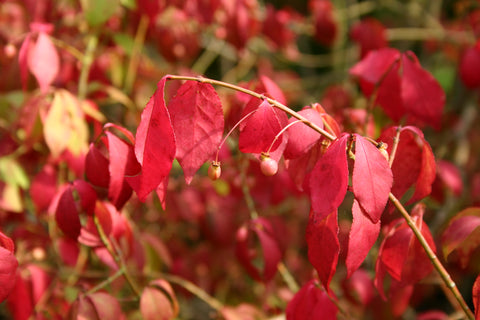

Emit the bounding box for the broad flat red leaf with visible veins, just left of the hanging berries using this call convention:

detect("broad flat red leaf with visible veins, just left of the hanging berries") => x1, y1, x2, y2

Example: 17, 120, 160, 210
168, 81, 224, 184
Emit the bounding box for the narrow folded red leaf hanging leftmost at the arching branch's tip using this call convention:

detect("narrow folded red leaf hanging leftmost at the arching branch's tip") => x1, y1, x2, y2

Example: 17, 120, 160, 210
127, 76, 176, 201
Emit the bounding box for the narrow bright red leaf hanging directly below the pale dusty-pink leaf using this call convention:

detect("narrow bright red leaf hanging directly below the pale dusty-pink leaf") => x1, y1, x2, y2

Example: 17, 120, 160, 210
345, 199, 380, 277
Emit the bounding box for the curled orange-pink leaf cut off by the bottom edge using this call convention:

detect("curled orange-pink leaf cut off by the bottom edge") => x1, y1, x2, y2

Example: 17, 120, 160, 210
140, 279, 178, 320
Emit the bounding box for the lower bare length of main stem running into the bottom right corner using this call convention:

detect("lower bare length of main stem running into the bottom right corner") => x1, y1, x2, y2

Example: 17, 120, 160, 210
389, 193, 475, 320
